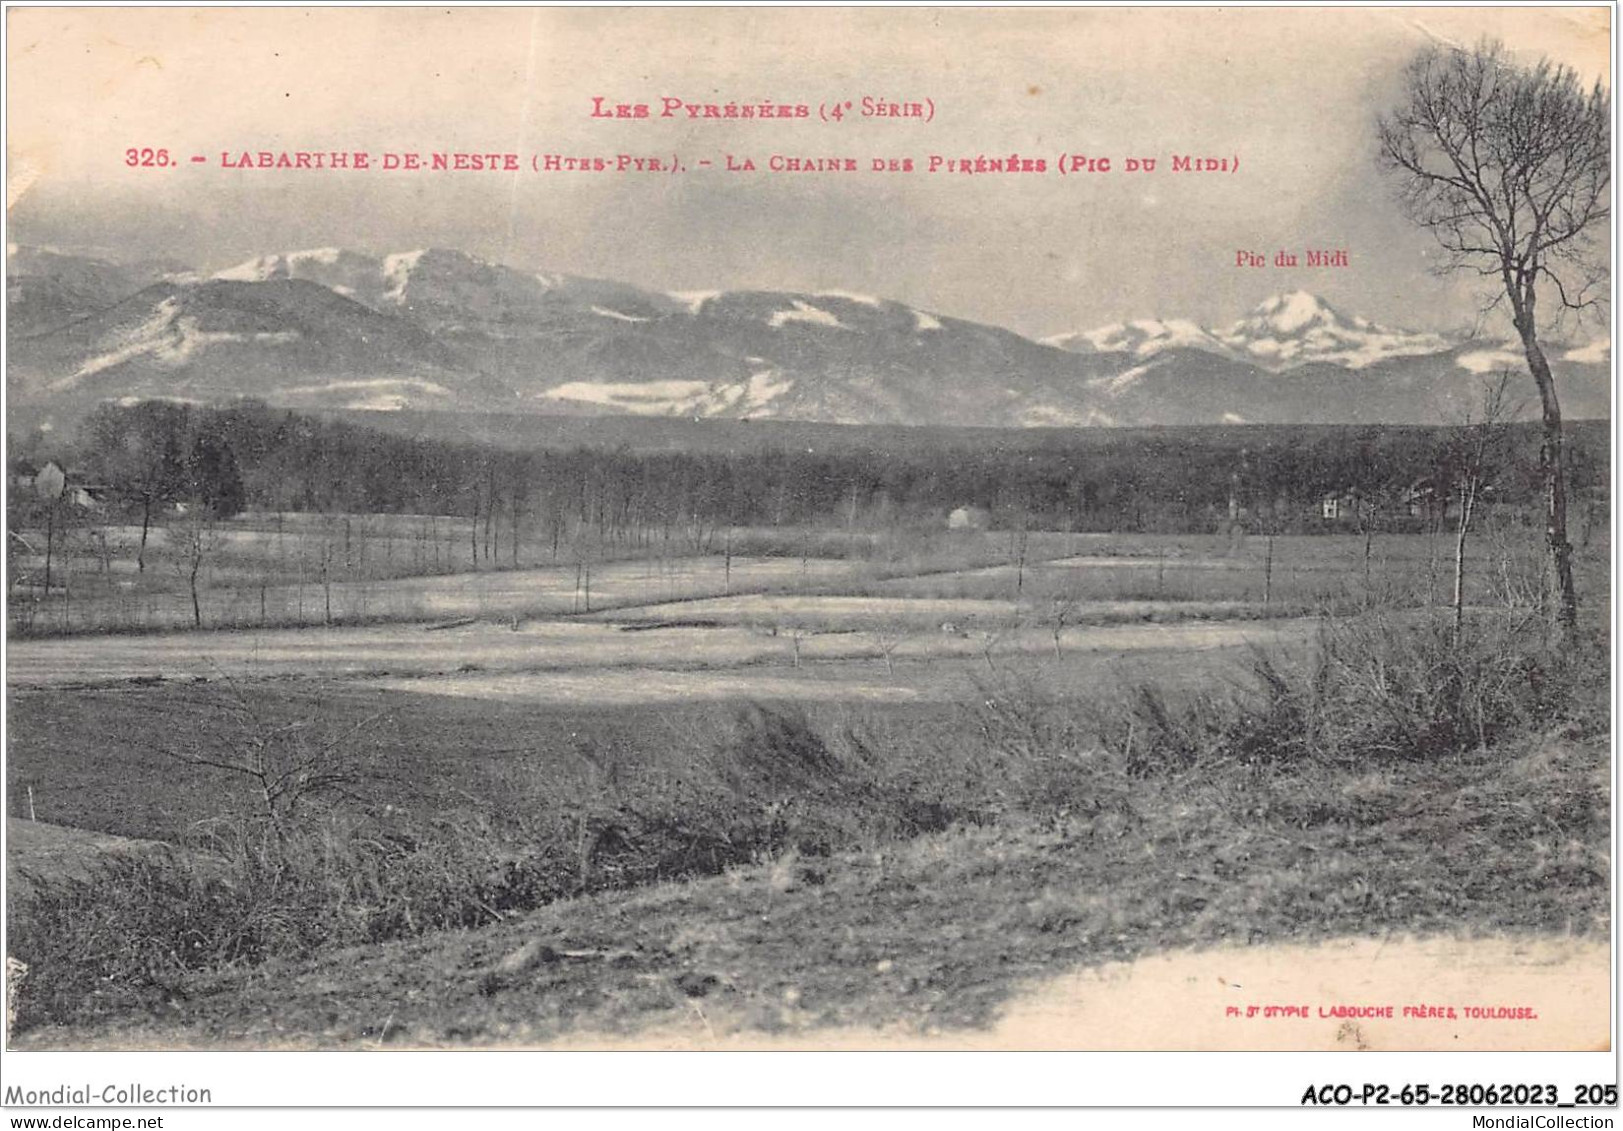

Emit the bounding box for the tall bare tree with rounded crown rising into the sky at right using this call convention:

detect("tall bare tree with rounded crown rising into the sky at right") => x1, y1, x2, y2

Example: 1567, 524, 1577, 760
1380, 42, 1612, 639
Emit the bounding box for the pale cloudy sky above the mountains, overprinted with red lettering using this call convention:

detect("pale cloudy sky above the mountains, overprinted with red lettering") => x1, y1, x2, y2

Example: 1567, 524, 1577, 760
6, 8, 1610, 336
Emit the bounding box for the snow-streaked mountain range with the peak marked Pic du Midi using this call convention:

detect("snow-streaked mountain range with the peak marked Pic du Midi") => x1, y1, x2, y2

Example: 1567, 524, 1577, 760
6, 245, 1610, 427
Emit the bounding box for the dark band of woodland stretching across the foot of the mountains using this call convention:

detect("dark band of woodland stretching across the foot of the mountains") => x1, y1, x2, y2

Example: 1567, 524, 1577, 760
13, 401, 1610, 534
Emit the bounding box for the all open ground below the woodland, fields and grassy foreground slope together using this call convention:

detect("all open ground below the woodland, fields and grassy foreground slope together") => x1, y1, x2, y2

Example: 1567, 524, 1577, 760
6, 509, 1610, 1047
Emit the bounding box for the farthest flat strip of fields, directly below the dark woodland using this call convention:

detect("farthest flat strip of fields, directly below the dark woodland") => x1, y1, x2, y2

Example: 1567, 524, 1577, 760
10, 514, 1608, 636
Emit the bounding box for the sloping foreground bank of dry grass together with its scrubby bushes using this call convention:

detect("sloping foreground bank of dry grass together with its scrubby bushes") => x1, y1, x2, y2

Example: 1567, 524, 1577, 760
13, 610, 1610, 1043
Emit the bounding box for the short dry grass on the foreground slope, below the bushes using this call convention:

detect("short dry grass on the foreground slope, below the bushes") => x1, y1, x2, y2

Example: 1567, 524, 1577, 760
21, 723, 1610, 1048
